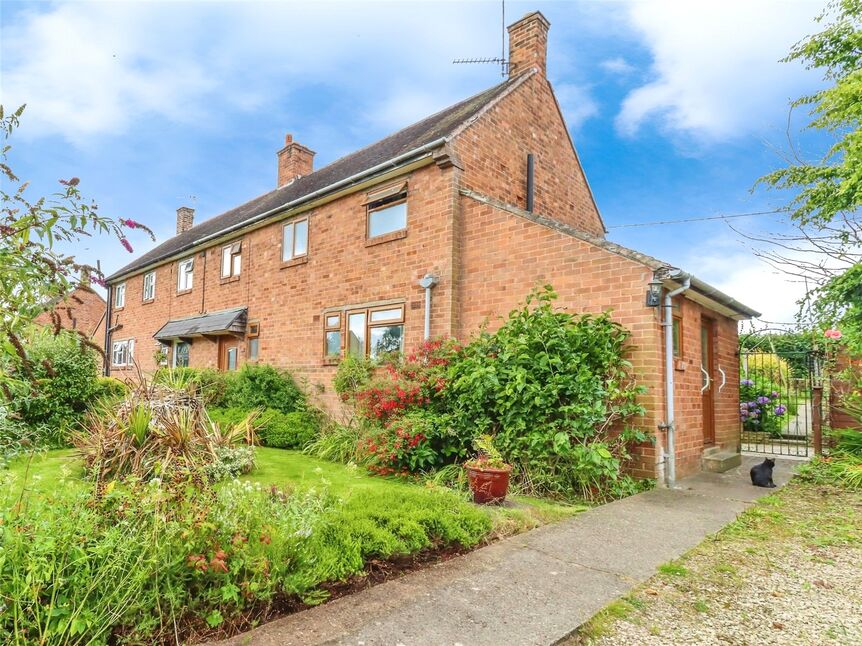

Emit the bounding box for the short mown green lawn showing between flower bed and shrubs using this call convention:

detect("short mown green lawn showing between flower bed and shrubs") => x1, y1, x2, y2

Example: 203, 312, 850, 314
0, 447, 587, 537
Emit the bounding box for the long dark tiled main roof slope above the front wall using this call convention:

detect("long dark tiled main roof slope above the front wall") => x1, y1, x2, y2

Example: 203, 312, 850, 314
108, 73, 528, 281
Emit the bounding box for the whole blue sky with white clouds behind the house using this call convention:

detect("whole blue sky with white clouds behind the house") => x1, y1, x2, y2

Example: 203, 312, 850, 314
0, 0, 827, 321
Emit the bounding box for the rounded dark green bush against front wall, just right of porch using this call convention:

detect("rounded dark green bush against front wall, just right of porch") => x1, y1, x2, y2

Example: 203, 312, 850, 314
223, 364, 305, 413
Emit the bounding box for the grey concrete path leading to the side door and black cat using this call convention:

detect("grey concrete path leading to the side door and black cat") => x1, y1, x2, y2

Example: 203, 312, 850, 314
223, 456, 798, 646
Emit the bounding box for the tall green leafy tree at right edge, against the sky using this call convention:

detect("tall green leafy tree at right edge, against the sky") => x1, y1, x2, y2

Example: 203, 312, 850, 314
758, 0, 862, 351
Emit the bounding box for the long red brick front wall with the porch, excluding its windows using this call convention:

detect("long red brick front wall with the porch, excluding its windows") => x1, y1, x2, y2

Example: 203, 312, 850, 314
113, 161, 456, 408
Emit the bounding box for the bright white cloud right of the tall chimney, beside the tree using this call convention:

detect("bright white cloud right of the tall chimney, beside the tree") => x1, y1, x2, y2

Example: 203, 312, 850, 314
617, 0, 822, 141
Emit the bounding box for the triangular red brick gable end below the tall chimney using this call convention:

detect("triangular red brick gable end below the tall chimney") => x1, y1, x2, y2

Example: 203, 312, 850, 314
454, 74, 604, 236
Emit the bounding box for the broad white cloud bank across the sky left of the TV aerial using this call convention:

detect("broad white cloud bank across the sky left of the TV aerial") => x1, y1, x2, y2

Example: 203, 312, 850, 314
0, 2, 497, 143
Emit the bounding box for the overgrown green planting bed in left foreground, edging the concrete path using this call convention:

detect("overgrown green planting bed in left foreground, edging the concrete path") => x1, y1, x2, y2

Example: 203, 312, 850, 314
0, 470, 491, 645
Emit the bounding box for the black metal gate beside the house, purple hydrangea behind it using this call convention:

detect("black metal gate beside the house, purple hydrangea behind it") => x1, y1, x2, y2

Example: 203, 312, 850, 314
739, 350, 822, 457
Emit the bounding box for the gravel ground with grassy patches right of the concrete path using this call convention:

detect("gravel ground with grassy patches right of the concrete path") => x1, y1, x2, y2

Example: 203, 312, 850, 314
568, 481, 862, 646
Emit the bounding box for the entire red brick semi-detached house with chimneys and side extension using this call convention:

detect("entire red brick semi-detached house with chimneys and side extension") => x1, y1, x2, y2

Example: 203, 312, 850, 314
105, 12, 757, 478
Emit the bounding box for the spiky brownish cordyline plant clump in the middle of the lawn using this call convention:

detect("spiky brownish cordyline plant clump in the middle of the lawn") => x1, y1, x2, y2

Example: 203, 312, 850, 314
73, 376, 258, 480
